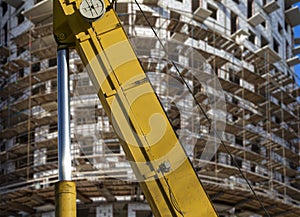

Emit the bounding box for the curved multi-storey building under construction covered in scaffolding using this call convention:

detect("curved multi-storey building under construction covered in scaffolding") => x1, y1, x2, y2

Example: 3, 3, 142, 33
0, 0, 300, 217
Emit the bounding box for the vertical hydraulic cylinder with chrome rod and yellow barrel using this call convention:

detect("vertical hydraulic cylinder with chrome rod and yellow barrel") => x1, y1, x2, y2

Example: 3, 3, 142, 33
55, 49, 76, 217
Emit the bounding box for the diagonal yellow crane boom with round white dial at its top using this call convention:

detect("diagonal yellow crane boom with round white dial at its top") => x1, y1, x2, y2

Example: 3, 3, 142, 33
53, 0, 217, 217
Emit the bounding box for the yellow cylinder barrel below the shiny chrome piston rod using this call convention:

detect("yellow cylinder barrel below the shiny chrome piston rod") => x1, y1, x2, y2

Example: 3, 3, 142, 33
55, 181, 76, 217
